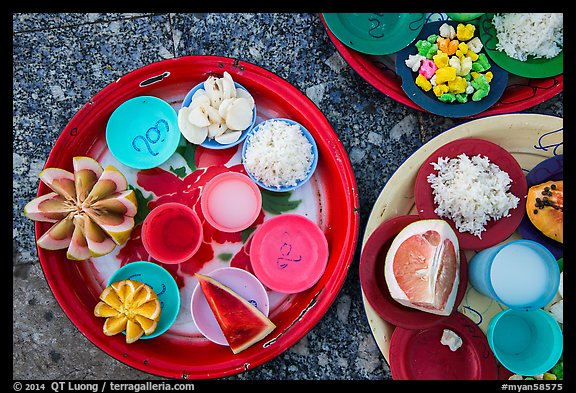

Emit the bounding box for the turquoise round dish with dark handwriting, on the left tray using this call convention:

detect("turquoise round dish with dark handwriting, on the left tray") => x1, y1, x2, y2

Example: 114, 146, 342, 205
106, 96, 181, 169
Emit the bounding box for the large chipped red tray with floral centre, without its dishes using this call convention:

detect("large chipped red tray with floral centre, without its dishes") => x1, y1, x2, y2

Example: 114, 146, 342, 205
35, 56, 359, 379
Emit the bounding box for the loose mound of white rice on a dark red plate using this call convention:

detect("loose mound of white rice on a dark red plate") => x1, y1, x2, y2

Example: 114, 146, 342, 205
427, 154, 520, 238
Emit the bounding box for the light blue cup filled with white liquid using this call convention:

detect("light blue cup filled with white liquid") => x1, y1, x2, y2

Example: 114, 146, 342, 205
468, 239, 560, 311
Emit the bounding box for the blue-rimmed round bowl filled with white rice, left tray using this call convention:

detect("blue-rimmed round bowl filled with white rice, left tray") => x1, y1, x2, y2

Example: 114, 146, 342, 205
242, 118, 318, 192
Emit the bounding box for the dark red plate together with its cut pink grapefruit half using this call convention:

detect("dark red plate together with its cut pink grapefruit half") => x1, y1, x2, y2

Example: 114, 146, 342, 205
360, 214, 468, 329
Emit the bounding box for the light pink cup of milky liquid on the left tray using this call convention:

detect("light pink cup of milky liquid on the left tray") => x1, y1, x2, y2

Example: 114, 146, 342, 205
200, 172, 262, 232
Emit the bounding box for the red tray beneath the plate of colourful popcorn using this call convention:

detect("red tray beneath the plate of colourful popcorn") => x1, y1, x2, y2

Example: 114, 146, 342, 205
320, 15, 564, 118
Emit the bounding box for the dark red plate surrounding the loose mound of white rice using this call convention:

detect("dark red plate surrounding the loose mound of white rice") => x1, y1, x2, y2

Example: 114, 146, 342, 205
414, 138, 527, 250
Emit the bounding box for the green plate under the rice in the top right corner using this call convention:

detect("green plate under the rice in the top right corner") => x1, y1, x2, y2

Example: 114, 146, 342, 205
480, 13, 564, 78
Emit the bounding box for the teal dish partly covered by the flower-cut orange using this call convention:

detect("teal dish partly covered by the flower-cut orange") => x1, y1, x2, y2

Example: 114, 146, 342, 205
108, 261, 180, 340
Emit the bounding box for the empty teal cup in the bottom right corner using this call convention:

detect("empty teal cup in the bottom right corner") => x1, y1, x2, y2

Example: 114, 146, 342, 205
487, 308, 564, 376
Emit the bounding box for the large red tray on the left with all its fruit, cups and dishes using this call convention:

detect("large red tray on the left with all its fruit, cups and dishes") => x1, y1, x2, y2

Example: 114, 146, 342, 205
31, 56, 359, 379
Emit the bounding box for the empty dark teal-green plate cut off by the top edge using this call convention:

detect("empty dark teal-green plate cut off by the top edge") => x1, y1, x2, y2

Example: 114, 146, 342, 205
322, 13, 426, 55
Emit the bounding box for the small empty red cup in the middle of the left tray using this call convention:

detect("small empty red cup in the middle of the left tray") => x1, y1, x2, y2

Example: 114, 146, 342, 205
142, 202, 203, 264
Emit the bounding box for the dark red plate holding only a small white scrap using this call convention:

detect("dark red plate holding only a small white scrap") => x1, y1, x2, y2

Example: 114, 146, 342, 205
390, 312, 499, 380
